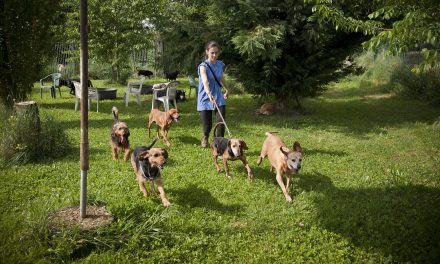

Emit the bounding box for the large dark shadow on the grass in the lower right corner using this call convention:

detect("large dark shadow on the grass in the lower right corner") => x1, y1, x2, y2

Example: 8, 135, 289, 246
299, 172, 440, 263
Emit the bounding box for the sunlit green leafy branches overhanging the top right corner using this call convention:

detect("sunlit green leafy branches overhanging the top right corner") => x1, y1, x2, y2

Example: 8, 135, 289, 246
306, 0, 440, 72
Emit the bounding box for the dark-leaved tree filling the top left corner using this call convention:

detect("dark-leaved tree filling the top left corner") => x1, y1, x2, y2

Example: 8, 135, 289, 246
0, 0, 59, 106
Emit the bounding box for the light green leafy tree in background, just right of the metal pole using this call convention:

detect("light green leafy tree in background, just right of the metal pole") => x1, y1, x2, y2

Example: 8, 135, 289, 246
89, 0, 161, 82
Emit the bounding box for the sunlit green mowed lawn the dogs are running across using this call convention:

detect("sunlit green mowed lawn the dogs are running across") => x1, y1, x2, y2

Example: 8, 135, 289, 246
0, 76, 440, 263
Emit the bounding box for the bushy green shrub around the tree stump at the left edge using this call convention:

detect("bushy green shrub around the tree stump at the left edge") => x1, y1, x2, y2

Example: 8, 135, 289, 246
0, 105, 70, 166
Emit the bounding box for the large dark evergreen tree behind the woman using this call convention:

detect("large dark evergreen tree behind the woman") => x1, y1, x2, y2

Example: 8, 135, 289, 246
155, 0, 359, 107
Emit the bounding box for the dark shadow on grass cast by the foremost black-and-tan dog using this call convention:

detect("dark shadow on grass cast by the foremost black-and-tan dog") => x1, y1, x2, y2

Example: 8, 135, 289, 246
170, 184, 241, 213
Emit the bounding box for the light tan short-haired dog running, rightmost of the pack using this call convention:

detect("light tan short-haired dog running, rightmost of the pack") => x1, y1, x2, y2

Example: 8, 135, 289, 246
257, 132, 302, 203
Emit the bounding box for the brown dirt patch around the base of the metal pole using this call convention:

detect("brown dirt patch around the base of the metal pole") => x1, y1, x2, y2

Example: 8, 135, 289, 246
49, 206, 113, 230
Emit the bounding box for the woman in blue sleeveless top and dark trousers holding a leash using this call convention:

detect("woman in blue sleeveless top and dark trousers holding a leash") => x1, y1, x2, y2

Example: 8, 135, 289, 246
197, 41, 228, 148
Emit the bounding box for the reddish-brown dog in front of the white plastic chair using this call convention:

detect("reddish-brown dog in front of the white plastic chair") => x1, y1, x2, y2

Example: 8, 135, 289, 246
148, 108, 180, 147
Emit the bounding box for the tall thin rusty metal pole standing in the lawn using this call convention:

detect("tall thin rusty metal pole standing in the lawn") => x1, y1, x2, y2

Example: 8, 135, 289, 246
79, 0, 89, 220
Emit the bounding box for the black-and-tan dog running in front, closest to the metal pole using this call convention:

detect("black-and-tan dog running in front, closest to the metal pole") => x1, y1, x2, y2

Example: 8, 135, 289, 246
131, 140, 171, 207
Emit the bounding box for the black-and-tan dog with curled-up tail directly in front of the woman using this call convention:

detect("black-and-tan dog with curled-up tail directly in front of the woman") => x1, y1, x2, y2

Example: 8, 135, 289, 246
211, 122, 254, 180
